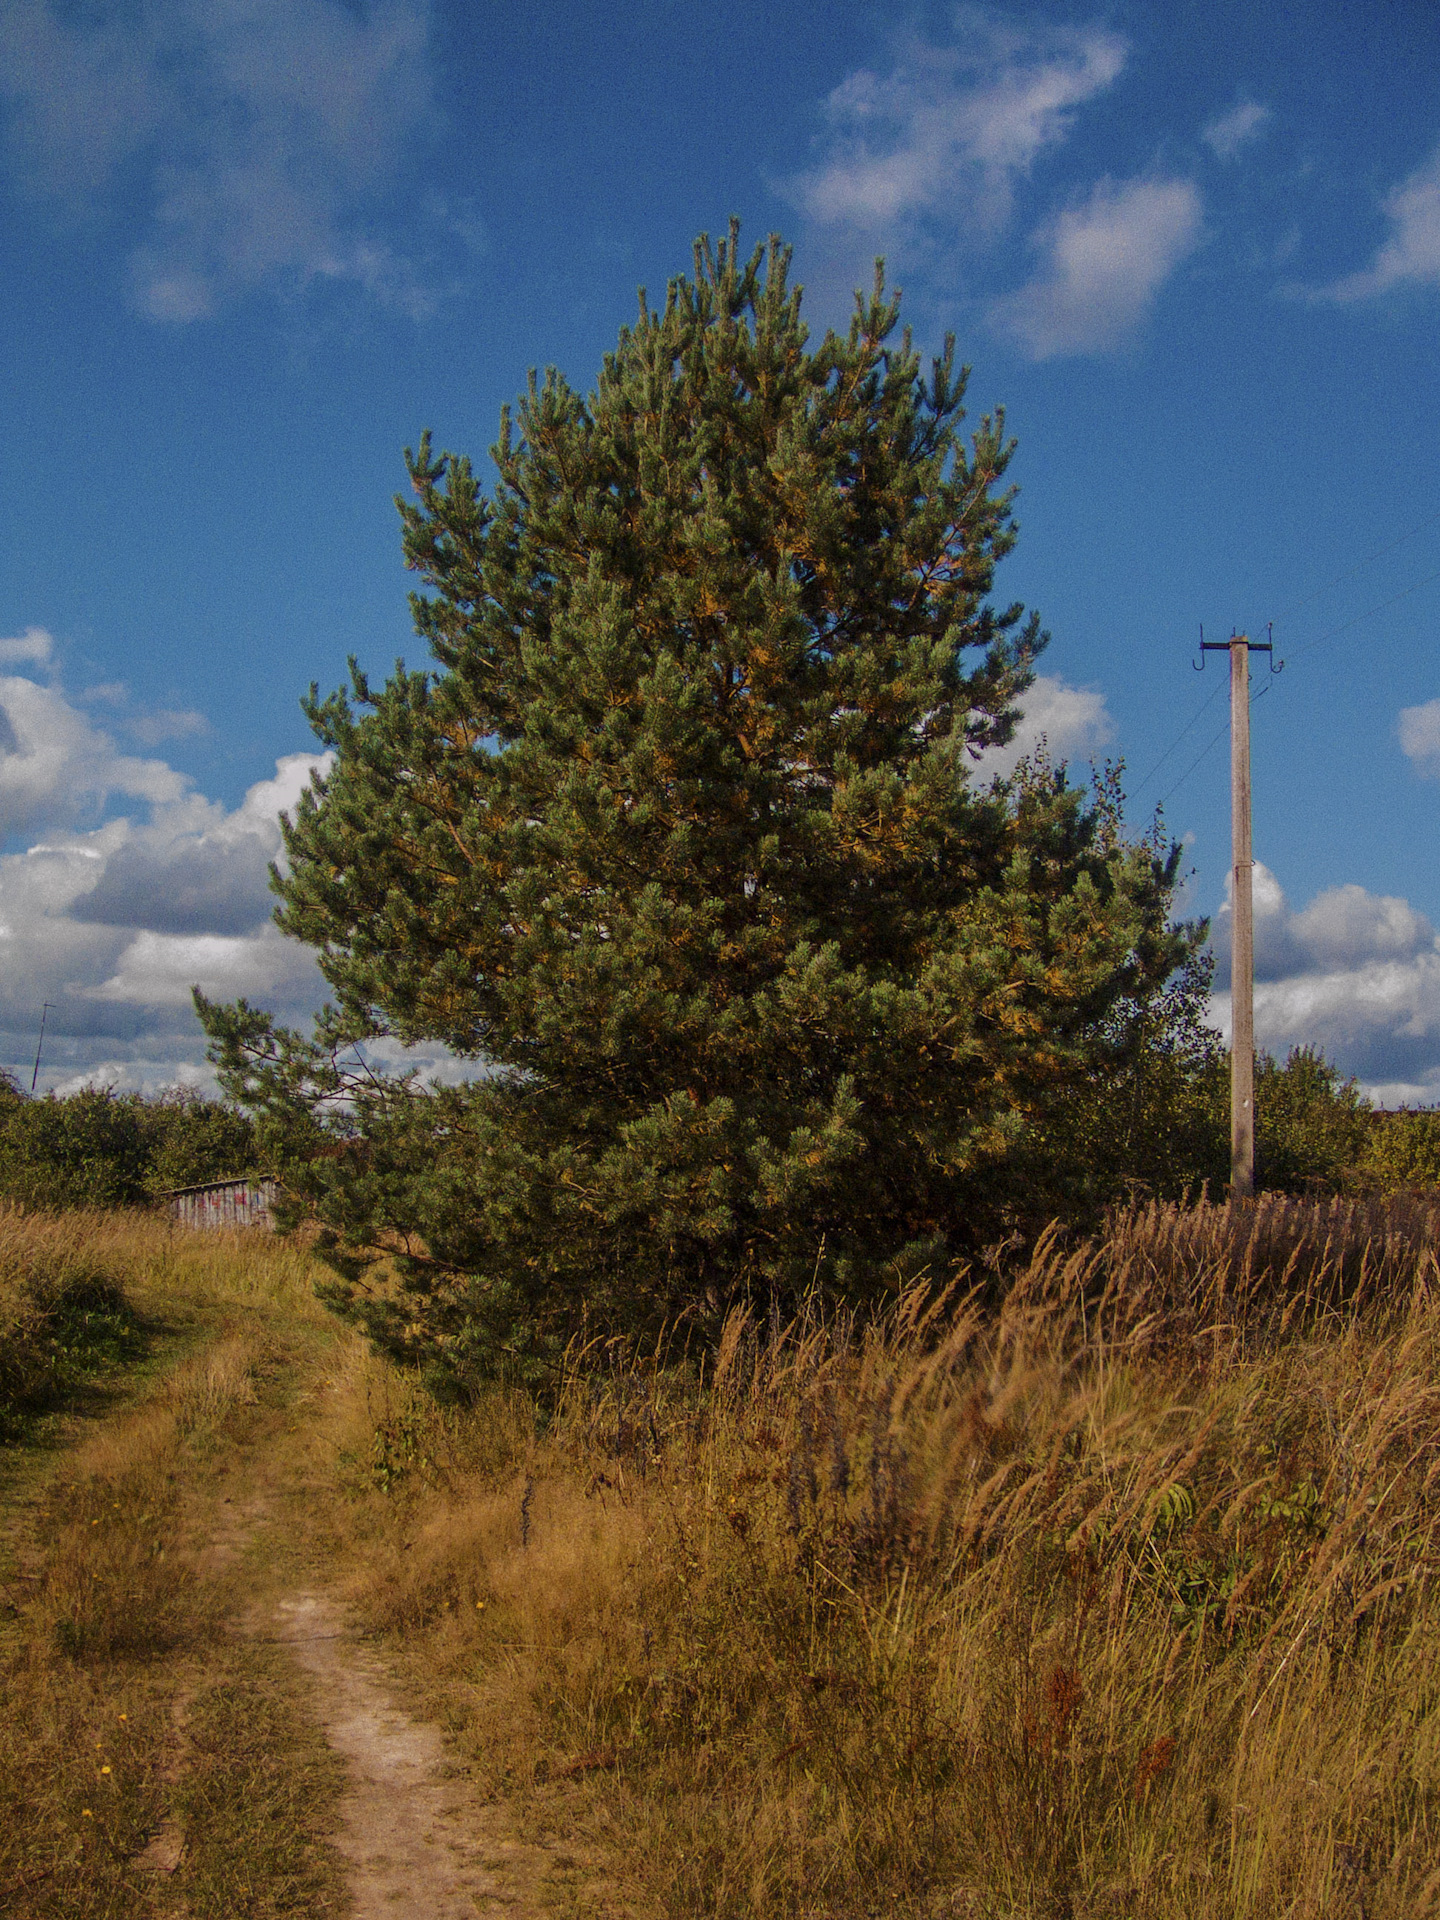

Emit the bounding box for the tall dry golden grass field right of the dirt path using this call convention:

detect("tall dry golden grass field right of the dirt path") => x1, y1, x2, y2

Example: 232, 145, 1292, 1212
324, 1202, 1440, 1920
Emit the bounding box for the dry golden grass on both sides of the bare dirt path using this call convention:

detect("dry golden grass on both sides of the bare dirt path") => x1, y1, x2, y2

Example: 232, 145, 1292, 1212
11, 1200, 1440, 1920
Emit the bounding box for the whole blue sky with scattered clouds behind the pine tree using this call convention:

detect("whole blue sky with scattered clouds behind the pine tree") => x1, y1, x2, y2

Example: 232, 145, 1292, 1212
0, 0, 1440, 1100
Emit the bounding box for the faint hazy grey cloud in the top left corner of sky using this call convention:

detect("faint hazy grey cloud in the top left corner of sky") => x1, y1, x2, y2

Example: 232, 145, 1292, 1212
0, 0, 439, 323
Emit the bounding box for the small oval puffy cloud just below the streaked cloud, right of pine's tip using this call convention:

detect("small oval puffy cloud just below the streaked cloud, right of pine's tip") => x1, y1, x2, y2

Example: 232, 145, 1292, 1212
991, 179, 1204, 359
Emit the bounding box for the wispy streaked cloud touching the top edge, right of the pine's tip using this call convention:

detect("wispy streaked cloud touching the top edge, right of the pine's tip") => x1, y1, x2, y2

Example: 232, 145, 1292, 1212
787, 8, 1127, 234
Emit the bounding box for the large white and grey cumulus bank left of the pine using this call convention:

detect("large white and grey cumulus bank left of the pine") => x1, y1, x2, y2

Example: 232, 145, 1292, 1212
0, 643, 337, 1089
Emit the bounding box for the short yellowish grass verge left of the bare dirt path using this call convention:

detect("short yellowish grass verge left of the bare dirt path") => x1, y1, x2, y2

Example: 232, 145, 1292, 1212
0, 1215, 340, 1920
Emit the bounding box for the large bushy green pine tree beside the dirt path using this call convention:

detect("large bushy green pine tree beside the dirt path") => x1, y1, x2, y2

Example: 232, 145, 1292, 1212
202, 227, 1192, 1380
